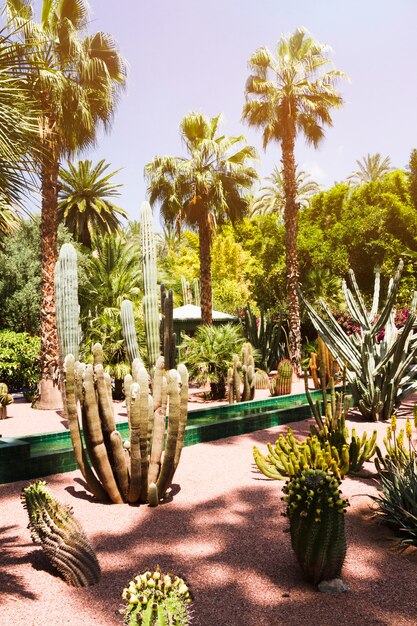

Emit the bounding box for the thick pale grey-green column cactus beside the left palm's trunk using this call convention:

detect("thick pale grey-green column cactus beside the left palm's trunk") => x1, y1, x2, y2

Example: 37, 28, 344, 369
55, 243, 80, 362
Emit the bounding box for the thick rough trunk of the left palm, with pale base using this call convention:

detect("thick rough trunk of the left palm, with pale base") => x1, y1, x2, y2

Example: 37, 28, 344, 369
38, 133, 62, 410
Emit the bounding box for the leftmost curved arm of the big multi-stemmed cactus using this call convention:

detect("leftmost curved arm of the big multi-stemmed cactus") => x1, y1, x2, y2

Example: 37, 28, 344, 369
64, 354, 108, 500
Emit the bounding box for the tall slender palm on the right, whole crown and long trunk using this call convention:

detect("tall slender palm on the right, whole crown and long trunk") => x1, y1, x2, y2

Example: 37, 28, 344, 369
243, 28, 344, 370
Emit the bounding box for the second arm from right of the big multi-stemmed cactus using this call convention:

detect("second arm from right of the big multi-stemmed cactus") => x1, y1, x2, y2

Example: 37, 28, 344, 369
156, 370, 181, 498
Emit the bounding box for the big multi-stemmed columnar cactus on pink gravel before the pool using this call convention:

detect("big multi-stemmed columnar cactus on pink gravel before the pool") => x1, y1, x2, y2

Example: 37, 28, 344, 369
65, 344, 188, 506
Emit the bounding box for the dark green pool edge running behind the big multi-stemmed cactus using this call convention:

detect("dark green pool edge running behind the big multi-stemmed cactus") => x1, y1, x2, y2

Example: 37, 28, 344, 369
0, 394, 324, 484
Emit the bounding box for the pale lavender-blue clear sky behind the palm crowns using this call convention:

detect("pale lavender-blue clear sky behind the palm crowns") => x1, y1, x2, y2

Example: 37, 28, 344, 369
35, 0, 417, 224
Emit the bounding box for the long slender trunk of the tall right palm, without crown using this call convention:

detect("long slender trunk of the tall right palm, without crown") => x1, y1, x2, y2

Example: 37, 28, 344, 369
281, 124, 301, 374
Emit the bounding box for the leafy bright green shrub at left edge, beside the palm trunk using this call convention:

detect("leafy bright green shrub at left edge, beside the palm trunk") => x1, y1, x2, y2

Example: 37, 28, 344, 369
0, 330, 41, 391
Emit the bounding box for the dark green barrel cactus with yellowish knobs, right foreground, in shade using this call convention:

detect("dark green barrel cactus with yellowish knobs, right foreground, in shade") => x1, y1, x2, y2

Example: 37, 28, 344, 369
283, 469, 349, 584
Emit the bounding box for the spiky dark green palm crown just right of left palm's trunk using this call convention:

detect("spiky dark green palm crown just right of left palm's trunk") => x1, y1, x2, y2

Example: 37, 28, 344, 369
58, 159, 127, 248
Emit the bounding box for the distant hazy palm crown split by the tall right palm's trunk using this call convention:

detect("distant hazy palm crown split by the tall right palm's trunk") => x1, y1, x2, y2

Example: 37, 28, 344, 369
251, 167, 320, 218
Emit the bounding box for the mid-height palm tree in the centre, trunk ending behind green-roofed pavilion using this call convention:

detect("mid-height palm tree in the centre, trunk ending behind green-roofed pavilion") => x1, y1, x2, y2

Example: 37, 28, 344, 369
145, 112, 257, 324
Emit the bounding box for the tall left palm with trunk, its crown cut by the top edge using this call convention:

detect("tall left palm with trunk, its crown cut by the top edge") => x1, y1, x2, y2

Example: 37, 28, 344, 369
6, 0, 125, 408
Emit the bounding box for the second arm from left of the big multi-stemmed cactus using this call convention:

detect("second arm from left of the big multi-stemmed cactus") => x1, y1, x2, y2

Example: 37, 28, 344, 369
84, 365, 123, 504
